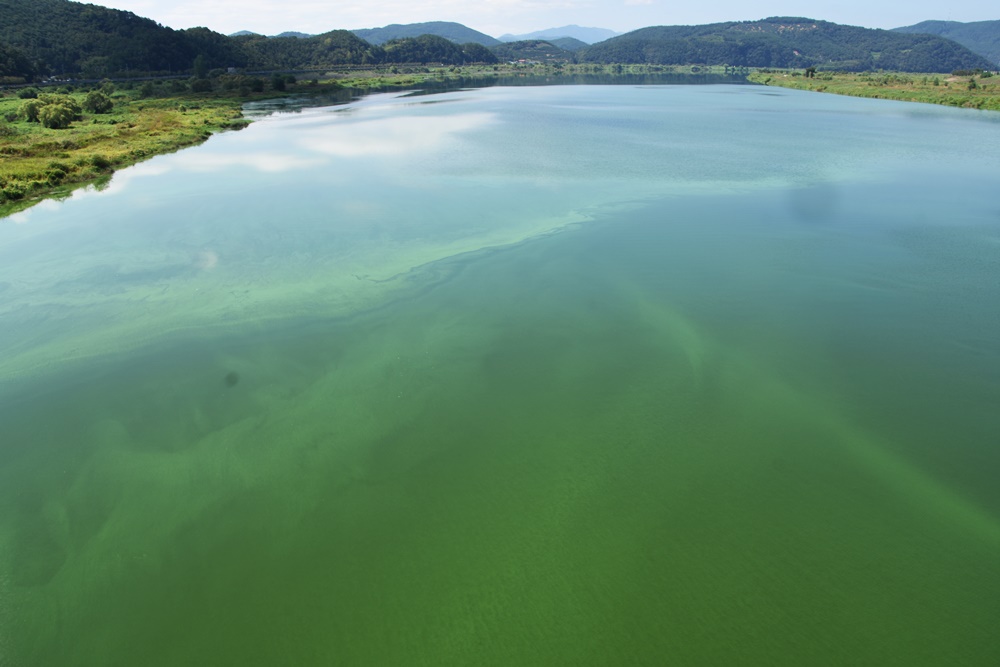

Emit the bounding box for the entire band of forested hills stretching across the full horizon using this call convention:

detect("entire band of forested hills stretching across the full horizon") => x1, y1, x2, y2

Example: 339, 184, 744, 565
0, 0, 995, 82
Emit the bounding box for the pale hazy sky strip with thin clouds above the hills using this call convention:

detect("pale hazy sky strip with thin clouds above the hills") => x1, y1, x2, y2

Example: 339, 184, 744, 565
92, 0, 1000, 37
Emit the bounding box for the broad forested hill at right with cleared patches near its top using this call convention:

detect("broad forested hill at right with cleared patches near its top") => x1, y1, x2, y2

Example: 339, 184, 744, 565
579, 17, 994, 72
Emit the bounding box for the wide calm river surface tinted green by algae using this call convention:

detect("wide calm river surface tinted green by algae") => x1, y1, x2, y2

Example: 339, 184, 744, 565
0, 86, 1000, 667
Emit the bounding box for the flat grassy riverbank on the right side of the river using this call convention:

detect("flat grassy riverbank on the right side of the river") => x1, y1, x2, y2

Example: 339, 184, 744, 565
748, 70, 1000, 111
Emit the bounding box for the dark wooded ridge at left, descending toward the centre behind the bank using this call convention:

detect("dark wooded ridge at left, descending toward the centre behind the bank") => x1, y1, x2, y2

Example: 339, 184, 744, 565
0, 0, 500, 80
